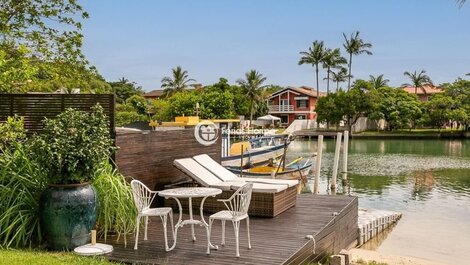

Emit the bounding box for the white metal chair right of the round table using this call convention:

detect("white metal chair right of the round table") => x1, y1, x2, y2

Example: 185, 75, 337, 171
209, 182, 253, 257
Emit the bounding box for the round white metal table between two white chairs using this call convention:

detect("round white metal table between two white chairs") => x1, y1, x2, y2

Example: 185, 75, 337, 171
158, 187, 222, 254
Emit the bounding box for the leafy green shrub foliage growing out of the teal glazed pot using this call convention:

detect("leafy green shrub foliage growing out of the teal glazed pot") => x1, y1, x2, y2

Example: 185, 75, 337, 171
33, 105, 114, 184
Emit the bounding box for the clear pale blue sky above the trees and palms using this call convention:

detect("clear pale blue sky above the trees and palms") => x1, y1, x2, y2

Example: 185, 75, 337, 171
80, 0, 470, 91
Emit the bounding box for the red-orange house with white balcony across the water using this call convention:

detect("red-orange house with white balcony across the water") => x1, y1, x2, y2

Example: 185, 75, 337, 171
268, 86, 326, 126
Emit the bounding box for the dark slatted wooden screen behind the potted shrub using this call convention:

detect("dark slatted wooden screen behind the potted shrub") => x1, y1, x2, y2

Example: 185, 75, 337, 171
0, 94, 115, 137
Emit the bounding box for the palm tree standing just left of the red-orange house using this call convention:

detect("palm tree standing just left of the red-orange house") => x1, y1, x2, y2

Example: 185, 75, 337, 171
237, 70, 266, 127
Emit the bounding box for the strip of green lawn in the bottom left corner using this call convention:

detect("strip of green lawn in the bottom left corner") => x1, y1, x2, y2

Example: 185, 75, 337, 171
0, 249, 118, 265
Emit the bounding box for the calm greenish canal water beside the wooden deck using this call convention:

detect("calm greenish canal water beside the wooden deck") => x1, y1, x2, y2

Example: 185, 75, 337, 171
288, 139, 470, 264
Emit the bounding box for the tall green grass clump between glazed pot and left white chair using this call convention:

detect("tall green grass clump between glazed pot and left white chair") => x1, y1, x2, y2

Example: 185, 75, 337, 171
93, 162, 137, 245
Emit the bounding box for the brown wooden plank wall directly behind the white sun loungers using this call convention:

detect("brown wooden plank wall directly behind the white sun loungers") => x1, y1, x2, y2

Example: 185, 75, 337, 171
116, 127, 222, 190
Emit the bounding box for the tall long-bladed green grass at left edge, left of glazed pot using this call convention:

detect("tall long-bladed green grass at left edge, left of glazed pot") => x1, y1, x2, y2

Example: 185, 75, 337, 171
0, 143, 47, 247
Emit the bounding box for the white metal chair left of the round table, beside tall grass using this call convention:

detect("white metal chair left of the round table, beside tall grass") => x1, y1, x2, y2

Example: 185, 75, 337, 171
131, 180, 174, 251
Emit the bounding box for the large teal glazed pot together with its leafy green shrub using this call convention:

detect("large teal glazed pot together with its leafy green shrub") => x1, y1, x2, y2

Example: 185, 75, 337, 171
32, 105, 114, 250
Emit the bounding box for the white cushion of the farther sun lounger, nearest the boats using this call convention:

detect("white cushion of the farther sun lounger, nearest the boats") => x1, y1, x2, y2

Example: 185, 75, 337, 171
193, 154, 299, 187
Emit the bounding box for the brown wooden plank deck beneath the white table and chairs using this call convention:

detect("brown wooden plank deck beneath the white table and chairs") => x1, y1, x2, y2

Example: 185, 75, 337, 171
103, 194, 358, 264
